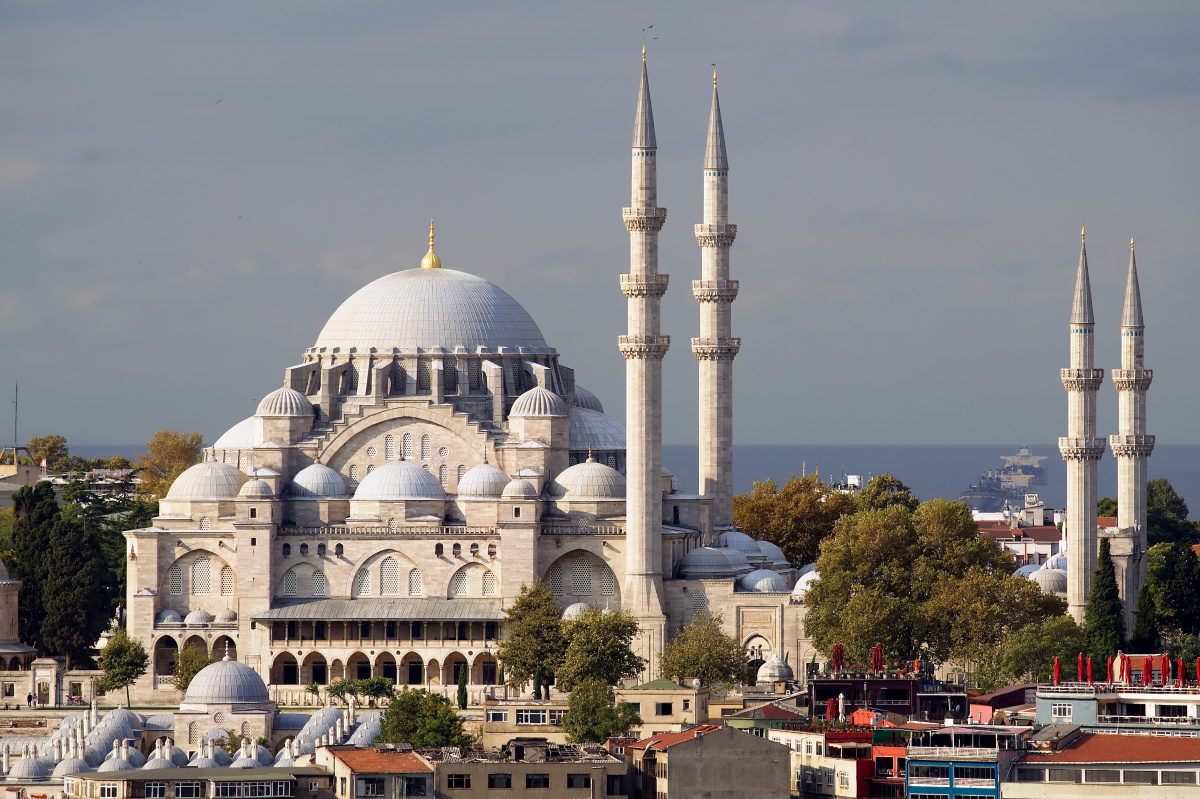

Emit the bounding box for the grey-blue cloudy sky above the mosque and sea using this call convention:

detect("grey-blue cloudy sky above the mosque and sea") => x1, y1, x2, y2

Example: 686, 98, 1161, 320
0, 0, 1200, 444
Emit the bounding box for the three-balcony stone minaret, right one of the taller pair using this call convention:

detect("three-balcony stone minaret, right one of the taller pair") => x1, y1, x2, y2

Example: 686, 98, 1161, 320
691, 70, 742, 528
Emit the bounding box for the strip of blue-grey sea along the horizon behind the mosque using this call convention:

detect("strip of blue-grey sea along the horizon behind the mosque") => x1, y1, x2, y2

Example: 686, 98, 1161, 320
71, 441, 1200, 506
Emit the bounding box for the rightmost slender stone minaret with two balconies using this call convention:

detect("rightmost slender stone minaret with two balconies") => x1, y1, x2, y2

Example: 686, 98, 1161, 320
1109, 238, 1154, 630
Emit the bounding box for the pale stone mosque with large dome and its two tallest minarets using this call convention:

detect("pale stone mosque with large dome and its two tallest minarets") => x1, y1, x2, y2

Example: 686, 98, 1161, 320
125, 52, 816, 705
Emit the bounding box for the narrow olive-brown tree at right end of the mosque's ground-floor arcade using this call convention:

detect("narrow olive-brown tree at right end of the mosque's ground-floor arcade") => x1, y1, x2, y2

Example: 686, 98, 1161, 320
496, 581, 566, 696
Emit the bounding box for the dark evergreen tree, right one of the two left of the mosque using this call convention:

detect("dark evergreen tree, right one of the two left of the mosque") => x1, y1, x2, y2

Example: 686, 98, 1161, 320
42, 505, 112, 669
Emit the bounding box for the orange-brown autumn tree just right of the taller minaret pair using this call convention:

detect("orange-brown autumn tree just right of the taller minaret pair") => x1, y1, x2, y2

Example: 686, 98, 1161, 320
733, 474, 852, 566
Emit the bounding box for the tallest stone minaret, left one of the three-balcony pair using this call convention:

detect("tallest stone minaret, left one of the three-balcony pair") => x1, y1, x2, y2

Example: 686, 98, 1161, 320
618, 43, 671, 674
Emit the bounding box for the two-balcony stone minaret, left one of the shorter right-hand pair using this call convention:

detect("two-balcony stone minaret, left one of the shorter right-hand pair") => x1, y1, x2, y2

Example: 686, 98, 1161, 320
1058, 225, 1104, 624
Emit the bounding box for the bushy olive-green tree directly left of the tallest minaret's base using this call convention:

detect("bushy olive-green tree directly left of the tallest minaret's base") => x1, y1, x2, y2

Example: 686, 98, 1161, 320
554, 608, 646, 691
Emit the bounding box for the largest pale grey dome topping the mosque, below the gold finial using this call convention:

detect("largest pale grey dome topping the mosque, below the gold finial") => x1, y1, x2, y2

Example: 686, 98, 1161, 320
316, 269, 546, 353
